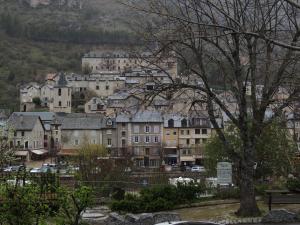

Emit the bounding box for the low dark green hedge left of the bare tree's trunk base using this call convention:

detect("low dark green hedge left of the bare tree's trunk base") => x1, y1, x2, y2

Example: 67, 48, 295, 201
110, 183, 204, 213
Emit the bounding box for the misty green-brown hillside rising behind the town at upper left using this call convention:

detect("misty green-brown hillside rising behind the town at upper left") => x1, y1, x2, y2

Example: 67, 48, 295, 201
0, 0, 136, 110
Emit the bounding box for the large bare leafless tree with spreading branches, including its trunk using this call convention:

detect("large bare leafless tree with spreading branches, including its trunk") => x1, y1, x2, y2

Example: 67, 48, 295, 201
126, 0, 300, 216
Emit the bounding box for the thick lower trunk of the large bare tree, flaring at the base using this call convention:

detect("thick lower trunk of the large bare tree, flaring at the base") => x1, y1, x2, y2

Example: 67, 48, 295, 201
236, 159, 260, 217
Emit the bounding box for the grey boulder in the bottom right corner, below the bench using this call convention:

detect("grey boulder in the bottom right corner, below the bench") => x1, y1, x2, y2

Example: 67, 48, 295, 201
261, 209, 299, 223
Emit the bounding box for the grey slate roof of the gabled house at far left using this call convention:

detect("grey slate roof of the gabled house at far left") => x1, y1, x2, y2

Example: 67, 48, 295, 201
7, 113, 40, 131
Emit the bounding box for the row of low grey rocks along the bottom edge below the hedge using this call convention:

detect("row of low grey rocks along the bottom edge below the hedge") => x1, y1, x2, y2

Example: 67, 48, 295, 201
83, 212, 181, 225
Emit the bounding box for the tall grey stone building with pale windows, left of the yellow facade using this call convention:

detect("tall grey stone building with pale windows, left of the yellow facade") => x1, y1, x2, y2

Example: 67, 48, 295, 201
116, 111, 163, 168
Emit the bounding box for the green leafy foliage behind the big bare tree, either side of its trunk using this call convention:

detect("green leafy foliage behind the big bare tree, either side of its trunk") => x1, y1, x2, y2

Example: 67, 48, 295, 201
204, 121, 296, 178
